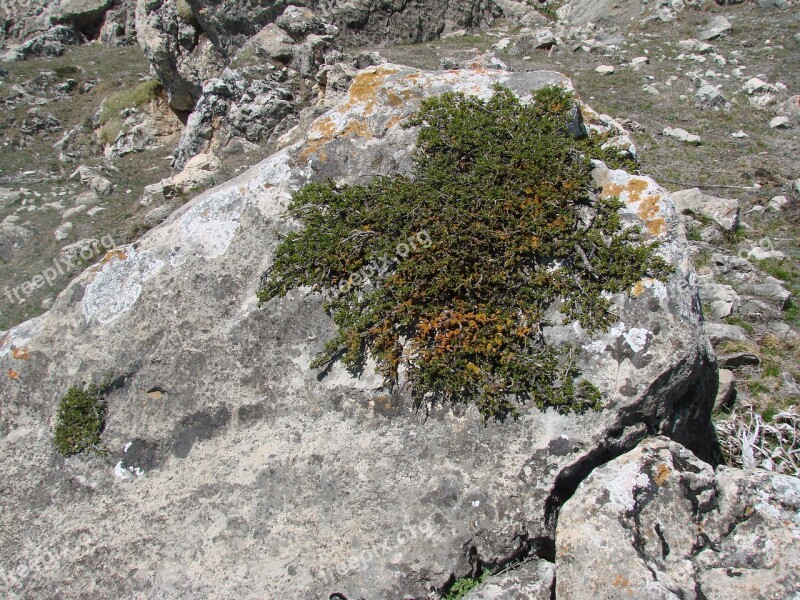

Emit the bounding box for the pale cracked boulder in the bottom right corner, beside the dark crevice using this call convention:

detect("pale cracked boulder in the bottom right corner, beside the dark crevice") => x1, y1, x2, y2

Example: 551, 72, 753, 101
556, 438, 800, 600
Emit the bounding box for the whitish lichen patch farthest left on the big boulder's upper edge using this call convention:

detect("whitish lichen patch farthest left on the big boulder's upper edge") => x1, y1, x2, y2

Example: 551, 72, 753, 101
83, 247, 164, 325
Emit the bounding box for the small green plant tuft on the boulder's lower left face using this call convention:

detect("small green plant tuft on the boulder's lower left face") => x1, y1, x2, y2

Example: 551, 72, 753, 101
54, 385, 107, 456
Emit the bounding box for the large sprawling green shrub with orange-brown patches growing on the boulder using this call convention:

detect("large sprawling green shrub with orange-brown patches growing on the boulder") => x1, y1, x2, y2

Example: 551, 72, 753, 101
258, 87, 670, 419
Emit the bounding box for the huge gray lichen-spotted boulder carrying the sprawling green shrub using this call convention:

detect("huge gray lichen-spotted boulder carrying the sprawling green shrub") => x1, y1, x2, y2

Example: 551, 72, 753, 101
0, 65, 716, 600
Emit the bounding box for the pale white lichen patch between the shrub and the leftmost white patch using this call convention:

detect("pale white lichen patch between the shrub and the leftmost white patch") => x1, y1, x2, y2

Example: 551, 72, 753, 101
170, 187, 244, 267
